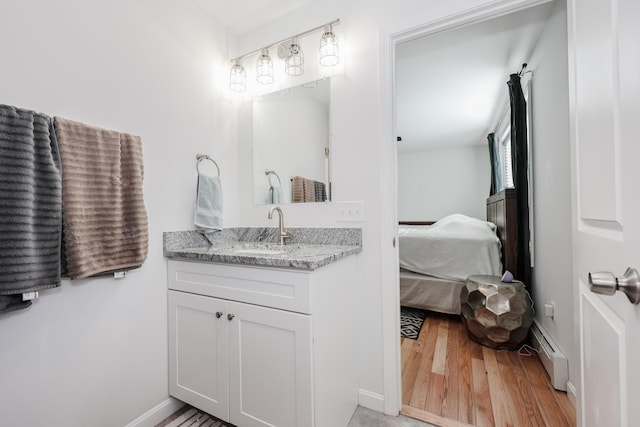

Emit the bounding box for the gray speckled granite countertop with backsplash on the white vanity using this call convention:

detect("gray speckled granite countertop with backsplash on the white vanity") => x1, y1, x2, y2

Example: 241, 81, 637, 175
163, 227, 362, 270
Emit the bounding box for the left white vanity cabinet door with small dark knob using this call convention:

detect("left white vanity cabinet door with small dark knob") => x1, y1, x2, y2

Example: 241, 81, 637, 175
169, 291, 229, 421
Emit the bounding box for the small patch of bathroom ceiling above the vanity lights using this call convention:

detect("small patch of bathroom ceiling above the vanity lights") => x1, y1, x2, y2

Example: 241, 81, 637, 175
194, 0, 318, 34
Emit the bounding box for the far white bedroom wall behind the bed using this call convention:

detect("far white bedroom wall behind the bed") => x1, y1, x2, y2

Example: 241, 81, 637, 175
398, 145, 491, 221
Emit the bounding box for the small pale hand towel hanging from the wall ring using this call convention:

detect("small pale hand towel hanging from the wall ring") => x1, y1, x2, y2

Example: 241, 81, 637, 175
194, 174, 222, 230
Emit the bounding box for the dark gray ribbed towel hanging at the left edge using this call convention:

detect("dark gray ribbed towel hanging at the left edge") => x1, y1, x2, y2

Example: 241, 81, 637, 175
0, 105, 62, 313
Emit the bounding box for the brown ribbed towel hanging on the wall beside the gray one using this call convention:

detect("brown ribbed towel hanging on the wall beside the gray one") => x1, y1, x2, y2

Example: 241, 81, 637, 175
54, 117, 149, 279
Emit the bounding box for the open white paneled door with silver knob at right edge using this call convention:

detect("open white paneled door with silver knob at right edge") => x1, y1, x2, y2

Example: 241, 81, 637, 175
569, 0, 640, 427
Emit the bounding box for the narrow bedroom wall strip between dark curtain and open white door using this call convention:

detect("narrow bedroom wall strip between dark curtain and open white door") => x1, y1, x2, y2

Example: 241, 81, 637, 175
529, 0, 578, 378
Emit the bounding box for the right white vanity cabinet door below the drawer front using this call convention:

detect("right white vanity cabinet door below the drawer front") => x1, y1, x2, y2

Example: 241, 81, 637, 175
228, 302, 313, 427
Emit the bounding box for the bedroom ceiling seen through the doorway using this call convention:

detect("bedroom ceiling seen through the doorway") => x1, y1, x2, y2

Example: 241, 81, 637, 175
396, 3, 553, 152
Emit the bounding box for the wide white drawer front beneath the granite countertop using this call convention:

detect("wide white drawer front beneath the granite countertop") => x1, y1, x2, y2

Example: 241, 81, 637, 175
168, 260, 311, 314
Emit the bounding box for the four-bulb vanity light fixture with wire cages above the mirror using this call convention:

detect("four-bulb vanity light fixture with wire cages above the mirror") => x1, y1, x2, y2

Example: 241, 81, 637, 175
229, 19, 340, 92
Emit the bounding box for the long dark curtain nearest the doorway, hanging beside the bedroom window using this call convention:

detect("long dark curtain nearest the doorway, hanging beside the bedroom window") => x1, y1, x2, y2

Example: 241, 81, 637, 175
507, 74, 532, 293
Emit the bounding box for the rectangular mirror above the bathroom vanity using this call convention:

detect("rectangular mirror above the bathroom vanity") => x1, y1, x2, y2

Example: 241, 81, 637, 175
253, 78, 331, 205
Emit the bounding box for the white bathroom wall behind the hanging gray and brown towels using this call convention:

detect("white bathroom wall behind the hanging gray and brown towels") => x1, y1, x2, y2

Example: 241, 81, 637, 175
0, 0, 238, 427
